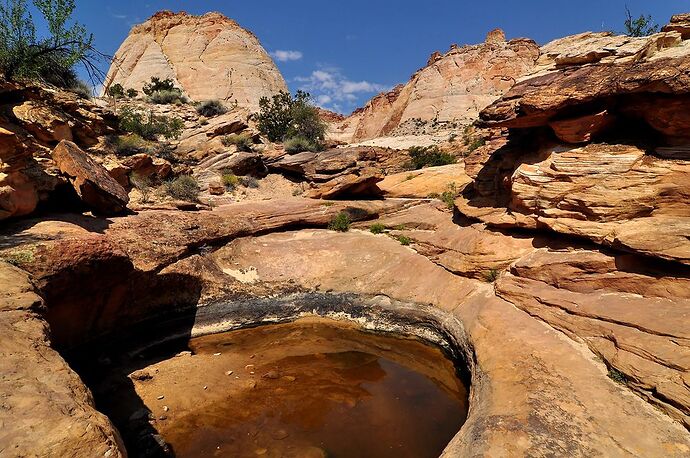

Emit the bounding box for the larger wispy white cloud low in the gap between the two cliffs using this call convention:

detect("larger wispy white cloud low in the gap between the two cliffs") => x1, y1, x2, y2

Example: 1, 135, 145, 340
295, 68, 390, 112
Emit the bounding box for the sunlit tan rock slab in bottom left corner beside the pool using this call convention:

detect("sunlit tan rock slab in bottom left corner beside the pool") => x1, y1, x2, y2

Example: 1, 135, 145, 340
0, 261, 127, 458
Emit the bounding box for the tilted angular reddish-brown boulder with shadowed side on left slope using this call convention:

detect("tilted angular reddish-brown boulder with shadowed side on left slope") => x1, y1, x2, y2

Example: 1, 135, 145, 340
52, 140, 129, 214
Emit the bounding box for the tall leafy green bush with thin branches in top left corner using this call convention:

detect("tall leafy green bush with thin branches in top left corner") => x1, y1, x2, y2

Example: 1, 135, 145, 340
0, 0, 100, 88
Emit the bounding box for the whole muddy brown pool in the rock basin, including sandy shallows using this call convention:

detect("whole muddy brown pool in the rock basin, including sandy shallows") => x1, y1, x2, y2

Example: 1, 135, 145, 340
83, 319, 468, 458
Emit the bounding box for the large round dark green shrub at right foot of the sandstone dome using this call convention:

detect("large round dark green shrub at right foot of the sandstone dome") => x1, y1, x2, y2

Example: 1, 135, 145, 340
256, 91, 326, 146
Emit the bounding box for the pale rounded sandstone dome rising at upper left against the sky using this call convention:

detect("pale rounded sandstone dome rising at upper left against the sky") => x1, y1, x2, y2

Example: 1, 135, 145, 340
106, 11, 287, 111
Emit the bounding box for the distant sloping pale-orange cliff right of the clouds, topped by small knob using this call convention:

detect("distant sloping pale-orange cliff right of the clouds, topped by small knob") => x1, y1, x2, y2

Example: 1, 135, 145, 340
332, 30, 539, 141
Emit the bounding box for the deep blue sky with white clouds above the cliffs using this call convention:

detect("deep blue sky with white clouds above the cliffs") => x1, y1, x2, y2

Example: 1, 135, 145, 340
63, 0, 690, 113
